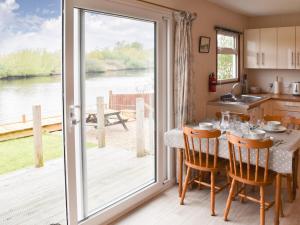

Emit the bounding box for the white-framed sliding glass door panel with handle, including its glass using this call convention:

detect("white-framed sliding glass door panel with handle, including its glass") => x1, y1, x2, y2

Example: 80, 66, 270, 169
65, 1, 170, 224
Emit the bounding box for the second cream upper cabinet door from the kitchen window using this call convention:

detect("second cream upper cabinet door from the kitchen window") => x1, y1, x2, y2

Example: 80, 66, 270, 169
260, 28, 277, 69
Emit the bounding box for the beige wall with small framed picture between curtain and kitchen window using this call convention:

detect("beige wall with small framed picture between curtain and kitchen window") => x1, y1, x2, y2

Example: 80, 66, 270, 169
146, 0, 247, 120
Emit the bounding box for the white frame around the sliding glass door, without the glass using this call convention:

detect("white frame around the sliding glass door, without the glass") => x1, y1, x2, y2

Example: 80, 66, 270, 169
63, 0, 174, 225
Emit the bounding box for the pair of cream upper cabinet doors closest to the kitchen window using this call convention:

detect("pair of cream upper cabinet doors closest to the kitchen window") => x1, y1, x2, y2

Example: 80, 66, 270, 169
244, 28, 277, 69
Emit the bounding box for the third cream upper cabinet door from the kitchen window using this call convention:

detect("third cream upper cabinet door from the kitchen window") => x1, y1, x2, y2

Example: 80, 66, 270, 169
277, 27, 297, 69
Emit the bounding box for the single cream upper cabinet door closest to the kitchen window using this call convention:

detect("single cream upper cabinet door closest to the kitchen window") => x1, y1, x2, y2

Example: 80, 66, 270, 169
244, 29, 260, 68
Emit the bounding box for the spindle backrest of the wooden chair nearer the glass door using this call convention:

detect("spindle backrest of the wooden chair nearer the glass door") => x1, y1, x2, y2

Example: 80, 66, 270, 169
183, 127, 221, 169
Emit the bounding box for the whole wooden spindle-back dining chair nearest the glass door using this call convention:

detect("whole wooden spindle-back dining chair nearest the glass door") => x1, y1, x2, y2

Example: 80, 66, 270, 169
180, 127, 228, 216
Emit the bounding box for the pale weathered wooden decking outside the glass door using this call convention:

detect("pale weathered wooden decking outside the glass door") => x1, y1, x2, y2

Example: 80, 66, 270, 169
0, 147, 154, 225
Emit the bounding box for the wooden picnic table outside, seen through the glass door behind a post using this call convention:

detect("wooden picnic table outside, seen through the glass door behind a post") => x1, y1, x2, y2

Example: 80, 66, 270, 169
85, 109, 128, 131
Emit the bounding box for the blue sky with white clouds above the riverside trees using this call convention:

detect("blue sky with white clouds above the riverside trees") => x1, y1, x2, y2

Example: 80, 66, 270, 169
0, 0, 154, 54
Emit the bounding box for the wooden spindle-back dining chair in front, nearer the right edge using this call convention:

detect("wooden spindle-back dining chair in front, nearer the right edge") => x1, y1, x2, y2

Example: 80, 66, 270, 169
224, 133, 276, 225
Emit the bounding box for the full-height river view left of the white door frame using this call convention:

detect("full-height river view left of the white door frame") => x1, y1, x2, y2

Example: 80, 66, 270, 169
0, 0, 66, 225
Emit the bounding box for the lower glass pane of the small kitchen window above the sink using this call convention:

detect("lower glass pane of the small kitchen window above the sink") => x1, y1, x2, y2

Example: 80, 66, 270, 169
218, 54, 237, 80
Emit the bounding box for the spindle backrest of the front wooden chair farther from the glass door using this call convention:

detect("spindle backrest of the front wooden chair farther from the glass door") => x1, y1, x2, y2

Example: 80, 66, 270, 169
227, 133, 273, 185
